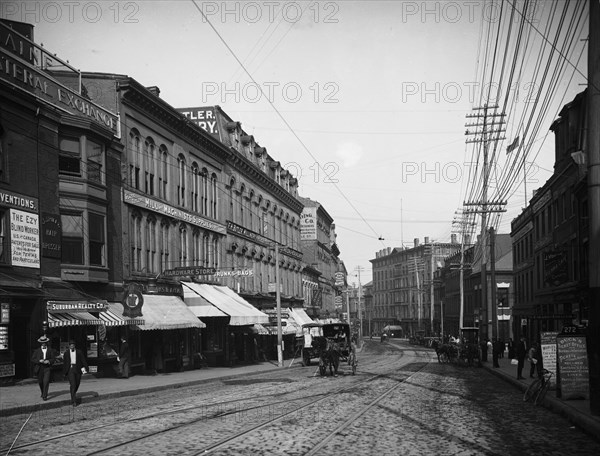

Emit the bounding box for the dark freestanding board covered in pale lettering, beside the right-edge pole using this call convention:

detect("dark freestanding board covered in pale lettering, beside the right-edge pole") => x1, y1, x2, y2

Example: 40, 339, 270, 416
556, 335, 590, 399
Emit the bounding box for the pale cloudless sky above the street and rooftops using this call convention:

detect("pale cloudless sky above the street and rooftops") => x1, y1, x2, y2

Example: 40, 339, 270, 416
0, 0, 587, 284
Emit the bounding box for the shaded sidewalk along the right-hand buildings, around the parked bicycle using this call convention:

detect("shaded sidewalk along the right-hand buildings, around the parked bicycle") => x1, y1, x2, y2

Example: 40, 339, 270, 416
483, 357, 600, 439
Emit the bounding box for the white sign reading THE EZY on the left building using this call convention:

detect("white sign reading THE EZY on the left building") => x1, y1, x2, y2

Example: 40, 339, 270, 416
10, 209, 40, 268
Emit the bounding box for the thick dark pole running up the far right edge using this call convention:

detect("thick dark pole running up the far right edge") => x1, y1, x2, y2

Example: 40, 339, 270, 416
587, 0, 600, 415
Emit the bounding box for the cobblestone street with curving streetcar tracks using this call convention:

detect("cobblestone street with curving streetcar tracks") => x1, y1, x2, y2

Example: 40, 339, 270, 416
0, 343, 599, 455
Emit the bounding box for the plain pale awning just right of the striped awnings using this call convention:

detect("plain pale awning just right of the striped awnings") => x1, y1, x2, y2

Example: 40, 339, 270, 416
134, 294, 206, 331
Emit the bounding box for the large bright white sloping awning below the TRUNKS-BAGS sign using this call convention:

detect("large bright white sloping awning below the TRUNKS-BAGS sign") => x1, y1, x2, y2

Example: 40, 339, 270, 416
182, 282, 269, 326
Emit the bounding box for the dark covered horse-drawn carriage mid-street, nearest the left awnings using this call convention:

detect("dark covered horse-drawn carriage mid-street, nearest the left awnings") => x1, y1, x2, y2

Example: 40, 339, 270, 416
302, 323, 357, 375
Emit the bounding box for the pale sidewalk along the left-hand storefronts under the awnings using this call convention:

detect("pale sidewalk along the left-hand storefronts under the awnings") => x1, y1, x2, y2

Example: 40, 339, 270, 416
0, 358, 302, 417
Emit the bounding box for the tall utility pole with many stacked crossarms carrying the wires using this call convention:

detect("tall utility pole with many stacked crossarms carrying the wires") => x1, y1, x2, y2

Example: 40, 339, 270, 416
465, 104, 506, 344
